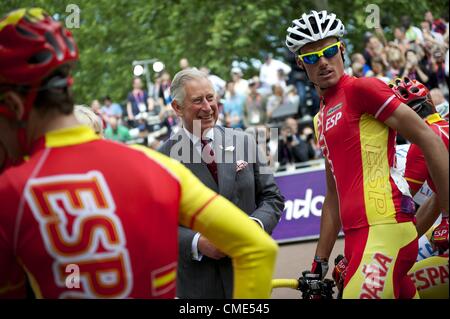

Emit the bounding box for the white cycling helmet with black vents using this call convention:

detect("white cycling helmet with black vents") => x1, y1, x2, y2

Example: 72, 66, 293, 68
286, 10, 345, 53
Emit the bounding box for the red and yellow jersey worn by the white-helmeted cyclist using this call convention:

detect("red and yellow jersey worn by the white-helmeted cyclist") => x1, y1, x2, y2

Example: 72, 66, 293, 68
315, 75, 415, 232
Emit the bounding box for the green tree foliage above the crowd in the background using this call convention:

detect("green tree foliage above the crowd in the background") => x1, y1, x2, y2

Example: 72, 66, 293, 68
0, 0, 449, 103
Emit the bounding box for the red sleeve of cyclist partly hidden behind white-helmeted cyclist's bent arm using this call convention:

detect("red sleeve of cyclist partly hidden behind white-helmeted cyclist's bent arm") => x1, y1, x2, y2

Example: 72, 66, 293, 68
405, 144, 428, 192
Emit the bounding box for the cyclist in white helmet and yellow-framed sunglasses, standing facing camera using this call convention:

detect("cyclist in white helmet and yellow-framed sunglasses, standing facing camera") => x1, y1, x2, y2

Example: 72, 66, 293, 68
286, 11, 449, 298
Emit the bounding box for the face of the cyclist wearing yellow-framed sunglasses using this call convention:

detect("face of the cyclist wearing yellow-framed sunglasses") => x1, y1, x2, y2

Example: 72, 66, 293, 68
297, 37, 345, 91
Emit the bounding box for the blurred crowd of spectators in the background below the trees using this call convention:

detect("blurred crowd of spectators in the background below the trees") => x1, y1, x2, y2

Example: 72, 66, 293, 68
79, 11, 449, 171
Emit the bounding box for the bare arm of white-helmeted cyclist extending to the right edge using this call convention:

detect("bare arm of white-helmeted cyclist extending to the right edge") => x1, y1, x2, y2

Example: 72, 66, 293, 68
385, 104, 449, 214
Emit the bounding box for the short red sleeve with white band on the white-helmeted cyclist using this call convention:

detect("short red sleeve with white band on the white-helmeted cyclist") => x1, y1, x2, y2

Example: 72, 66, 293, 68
354, 78, 401, 122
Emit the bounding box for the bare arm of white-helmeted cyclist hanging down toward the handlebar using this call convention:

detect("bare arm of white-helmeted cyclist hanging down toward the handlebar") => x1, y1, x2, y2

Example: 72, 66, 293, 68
316, 160, 341, 259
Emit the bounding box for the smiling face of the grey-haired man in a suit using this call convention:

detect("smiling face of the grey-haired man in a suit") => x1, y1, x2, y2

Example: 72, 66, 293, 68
175, 79, 219, 134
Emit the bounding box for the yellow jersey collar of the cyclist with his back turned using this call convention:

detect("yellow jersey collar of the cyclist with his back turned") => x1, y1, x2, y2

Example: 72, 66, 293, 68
31, 125, 100, 153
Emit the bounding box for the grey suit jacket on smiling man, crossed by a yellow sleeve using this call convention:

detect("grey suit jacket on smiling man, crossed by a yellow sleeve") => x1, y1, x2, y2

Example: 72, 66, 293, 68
159, 126, 284, 298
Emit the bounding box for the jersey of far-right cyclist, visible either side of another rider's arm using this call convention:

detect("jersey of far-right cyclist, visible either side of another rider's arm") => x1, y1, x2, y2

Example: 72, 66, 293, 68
405, 113, 449, 193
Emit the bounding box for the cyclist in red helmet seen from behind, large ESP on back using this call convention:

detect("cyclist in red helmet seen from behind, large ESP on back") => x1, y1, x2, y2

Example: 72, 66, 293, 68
0, 8, 277, 298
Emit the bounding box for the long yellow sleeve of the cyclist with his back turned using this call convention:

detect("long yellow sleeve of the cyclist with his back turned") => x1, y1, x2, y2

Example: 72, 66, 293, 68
130, 148, 278, 298
